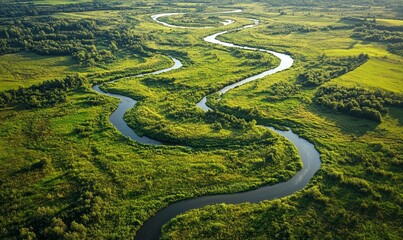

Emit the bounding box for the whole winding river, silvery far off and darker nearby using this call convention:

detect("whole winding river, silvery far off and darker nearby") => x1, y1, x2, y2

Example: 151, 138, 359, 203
93, 10, 320, 240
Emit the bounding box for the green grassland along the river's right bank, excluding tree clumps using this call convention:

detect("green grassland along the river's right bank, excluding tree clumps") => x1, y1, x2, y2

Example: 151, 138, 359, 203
159, 2, 403, 239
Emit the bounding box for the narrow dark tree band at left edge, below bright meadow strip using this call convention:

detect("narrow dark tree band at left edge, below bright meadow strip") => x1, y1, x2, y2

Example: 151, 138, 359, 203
0, 75, 87, 108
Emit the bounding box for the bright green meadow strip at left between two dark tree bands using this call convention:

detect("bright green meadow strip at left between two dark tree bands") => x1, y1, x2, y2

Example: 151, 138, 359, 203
0, 53, 171, 90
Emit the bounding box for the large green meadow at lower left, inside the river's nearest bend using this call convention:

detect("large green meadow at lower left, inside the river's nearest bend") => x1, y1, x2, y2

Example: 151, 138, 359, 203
1, 86, 298, 238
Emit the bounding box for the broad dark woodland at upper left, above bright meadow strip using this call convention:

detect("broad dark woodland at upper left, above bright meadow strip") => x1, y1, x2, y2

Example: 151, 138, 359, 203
0, 17, 150, 67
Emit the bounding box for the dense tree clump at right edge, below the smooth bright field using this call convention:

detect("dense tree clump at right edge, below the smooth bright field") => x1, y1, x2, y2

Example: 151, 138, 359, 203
314, 85, 403, 122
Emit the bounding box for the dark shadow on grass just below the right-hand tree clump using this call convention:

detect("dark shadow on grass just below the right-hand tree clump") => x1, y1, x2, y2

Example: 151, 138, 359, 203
309, 105, 379, 137
